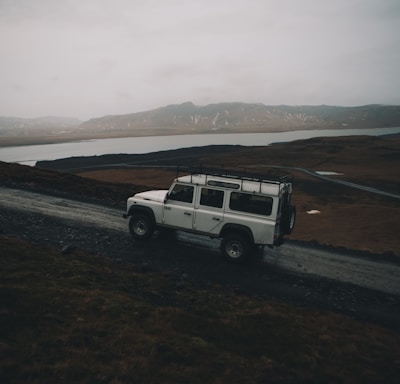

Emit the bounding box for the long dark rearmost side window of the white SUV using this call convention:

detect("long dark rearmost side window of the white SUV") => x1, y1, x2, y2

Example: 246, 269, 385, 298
229, 192, 273, 216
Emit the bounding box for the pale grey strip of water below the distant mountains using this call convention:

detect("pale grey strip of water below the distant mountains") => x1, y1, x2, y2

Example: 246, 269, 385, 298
0, 127, 400, 165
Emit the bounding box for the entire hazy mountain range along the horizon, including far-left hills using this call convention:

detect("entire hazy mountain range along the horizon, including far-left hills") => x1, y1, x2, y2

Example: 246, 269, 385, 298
0, 102, 400, 138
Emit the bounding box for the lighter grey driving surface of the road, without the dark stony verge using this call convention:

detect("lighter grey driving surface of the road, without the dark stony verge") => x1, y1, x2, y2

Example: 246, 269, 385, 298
0, 188, 400, 295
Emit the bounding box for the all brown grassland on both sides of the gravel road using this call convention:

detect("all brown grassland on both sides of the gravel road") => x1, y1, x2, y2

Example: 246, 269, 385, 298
0, 134, 400, 384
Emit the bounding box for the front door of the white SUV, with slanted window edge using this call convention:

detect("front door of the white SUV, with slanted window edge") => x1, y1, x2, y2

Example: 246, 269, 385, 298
163, 184, 194, 229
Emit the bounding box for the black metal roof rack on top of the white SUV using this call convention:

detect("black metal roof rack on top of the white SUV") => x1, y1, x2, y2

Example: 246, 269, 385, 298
176, 166, 293, 184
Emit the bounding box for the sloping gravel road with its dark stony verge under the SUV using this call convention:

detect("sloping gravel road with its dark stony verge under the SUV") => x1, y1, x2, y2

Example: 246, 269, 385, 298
0, 187, 400, 329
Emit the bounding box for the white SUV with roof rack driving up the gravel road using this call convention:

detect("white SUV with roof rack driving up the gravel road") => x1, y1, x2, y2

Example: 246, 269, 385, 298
123, 166, 296, 262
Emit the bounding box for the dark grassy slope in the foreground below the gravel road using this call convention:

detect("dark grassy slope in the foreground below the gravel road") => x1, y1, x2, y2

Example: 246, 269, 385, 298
0, 237, 400, 384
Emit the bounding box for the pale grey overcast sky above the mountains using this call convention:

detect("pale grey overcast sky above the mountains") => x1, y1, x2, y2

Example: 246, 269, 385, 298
0, 0, 400, 120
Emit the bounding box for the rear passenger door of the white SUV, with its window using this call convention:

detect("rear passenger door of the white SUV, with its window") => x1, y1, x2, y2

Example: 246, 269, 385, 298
194, 187, 224, 234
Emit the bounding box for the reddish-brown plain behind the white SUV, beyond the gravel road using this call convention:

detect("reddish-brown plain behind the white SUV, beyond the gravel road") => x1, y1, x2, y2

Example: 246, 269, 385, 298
78, 137, 400, 256
